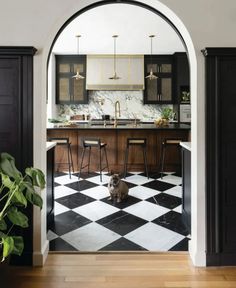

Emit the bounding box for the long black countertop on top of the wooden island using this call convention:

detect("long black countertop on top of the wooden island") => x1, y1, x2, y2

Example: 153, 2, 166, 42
47, 122, 191, 130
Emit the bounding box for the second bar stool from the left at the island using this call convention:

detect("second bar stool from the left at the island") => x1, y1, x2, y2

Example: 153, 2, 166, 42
79, 138, 109, 182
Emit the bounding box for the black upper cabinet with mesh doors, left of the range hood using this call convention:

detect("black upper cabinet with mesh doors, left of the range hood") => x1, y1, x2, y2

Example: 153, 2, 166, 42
55, 55, 88, 104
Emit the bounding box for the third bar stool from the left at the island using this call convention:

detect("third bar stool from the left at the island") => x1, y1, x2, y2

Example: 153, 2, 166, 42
124, 138, 149, 179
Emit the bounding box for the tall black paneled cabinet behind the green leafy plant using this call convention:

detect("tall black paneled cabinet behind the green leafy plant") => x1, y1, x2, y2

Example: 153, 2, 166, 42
0, 46, 36, 265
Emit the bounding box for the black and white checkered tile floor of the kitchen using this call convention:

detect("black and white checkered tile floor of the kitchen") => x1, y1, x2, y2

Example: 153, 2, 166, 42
48, 172, 189, 251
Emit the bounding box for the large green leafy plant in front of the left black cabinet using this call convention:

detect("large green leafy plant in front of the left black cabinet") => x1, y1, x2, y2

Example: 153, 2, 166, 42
0, 153, 45, 261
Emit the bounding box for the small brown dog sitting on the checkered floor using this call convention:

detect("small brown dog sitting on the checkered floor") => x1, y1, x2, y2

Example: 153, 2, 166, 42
108, 174, 129, 203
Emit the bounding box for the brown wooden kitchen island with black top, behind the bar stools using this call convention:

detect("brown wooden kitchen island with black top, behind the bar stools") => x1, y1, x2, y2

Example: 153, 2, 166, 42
47, 123, 191, 173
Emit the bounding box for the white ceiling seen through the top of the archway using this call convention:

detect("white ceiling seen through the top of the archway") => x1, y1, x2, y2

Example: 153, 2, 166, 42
52, 4, 185, 54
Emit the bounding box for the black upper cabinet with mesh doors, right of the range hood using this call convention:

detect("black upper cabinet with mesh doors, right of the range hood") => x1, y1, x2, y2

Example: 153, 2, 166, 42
144, 55, 173, 104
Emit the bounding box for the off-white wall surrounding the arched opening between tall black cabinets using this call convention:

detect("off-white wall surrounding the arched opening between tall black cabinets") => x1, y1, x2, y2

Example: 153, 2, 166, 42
0, 0, 236, 265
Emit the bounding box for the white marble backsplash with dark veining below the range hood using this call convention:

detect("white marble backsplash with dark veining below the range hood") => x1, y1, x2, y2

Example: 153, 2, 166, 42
57, 91, 172, 121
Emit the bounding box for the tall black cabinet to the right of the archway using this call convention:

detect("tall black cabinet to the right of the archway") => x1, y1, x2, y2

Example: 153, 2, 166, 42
203, 48, 236, 266
